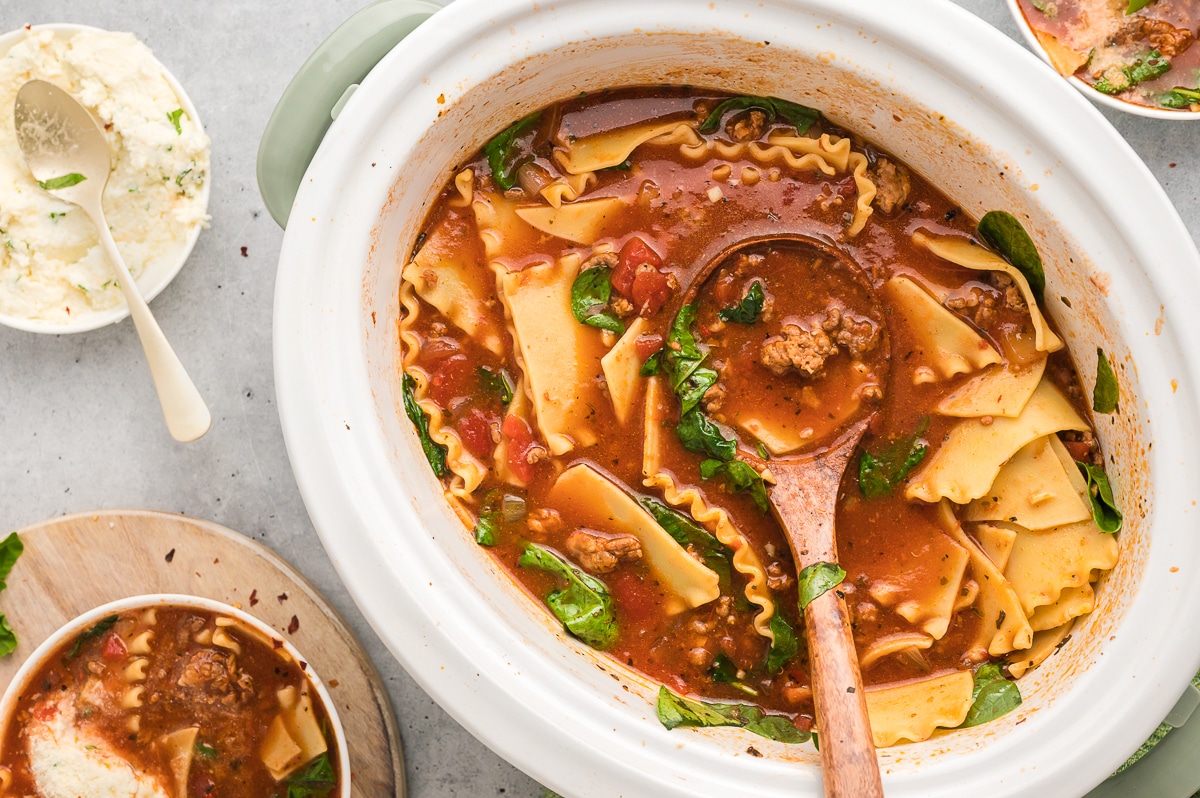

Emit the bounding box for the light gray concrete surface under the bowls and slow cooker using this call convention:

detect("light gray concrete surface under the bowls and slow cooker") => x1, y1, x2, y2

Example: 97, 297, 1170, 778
0, 0, 1200, 798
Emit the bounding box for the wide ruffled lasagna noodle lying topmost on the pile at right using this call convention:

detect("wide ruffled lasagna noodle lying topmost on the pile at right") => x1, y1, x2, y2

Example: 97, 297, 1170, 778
905, 379, 1090, 504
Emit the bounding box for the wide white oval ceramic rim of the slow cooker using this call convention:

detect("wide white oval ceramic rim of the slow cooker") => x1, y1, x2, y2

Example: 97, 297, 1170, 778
274, 0, 1200, 798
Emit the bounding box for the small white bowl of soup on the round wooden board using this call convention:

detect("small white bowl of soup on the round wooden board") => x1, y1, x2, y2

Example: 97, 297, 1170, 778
0, 594, 350, 798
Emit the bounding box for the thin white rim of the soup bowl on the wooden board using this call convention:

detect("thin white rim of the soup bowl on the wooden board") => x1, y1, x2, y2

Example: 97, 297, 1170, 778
0, 593, 352, 798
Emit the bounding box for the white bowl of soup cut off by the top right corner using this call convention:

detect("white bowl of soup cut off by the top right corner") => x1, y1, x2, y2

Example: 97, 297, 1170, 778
1008, 0, 1200, 120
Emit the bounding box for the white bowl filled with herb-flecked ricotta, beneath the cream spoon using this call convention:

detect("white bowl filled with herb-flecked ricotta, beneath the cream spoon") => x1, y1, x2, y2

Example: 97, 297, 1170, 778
0, 24, 210, 334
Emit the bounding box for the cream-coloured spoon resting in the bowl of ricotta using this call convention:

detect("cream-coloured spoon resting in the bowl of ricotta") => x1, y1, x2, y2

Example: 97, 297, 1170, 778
13, 80, 212, 443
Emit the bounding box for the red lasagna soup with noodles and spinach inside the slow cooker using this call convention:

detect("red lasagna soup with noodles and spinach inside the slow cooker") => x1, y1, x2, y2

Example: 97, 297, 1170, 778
400, 88, 1121, 746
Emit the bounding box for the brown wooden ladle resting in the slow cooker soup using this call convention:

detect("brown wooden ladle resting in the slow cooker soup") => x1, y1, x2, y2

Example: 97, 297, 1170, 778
684, 234, 889, 798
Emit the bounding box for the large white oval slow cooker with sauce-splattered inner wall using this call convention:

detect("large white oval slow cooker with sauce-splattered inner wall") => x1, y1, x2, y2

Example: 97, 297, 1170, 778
267, 0, 1200, 798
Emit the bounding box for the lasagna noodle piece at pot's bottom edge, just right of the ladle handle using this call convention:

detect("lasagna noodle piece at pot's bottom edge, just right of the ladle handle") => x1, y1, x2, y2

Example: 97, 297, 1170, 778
865, 671, 974, 748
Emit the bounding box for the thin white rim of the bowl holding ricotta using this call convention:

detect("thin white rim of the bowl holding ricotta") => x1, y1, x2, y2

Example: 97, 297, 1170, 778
0, 23, 212, 335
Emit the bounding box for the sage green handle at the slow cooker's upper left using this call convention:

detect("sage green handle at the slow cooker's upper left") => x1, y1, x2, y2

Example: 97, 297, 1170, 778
258, 0, 442, 227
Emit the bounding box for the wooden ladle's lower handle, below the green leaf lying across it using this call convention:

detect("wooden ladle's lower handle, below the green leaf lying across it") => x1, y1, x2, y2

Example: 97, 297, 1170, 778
804, 589, 883, 798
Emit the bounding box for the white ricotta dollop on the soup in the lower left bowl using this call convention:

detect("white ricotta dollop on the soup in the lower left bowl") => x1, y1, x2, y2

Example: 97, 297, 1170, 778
26, 698, 170, 798
